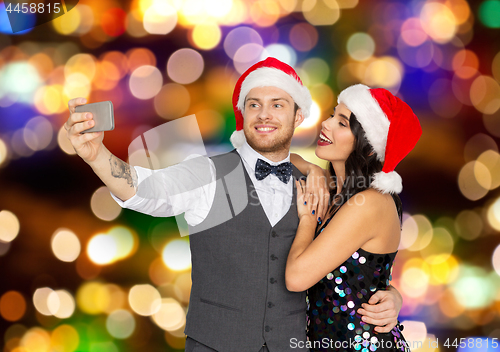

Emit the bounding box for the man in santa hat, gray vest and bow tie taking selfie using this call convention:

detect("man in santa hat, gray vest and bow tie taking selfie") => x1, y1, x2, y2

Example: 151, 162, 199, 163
65, 58, 401, 352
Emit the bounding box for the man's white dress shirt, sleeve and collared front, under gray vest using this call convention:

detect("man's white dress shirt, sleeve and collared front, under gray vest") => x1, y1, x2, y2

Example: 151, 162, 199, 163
111, 142, 293, 226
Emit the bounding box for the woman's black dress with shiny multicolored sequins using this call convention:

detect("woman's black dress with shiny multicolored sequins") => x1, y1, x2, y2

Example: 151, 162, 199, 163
306, 210, 410, 352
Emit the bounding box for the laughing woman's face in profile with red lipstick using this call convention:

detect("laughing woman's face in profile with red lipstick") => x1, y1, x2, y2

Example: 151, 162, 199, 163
316, 103, 355, 163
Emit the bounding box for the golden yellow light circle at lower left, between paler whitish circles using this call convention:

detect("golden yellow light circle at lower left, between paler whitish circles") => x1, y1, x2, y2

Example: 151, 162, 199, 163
76, 282, 111, 315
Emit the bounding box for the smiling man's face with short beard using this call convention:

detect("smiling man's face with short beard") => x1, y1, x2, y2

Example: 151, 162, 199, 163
243, 87, 304, 153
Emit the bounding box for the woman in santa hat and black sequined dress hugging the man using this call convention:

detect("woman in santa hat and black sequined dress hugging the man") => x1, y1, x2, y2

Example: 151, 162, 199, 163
286, 85, 422, 352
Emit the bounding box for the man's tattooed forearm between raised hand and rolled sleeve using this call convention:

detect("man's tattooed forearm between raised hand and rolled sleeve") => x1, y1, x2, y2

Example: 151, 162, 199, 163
88, 146, 137, 201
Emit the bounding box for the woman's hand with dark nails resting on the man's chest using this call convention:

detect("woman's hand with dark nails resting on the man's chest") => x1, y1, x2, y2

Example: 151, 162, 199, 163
305, 164, 330, 224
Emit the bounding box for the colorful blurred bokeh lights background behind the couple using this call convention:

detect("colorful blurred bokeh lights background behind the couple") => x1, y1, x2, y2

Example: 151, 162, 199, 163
0, 0, 500, 352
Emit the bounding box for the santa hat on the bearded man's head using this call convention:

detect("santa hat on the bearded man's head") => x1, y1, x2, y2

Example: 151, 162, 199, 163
231, 57, 312, 148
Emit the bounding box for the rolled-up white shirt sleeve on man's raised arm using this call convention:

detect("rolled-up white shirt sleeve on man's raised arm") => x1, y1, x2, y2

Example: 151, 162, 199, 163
111, 155, 216, 226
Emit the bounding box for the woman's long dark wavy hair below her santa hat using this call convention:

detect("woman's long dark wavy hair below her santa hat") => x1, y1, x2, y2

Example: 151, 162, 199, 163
328, 113, 403, 223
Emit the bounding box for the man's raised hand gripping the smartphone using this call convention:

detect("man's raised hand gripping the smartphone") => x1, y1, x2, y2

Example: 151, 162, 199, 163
64, 98, 108, 163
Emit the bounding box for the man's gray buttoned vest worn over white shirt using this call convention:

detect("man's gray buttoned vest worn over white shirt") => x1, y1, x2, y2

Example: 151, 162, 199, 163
184, 150, 308, 352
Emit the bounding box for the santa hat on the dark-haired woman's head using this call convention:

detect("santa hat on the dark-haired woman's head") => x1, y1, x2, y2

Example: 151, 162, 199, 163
337, 84, 422, 193
